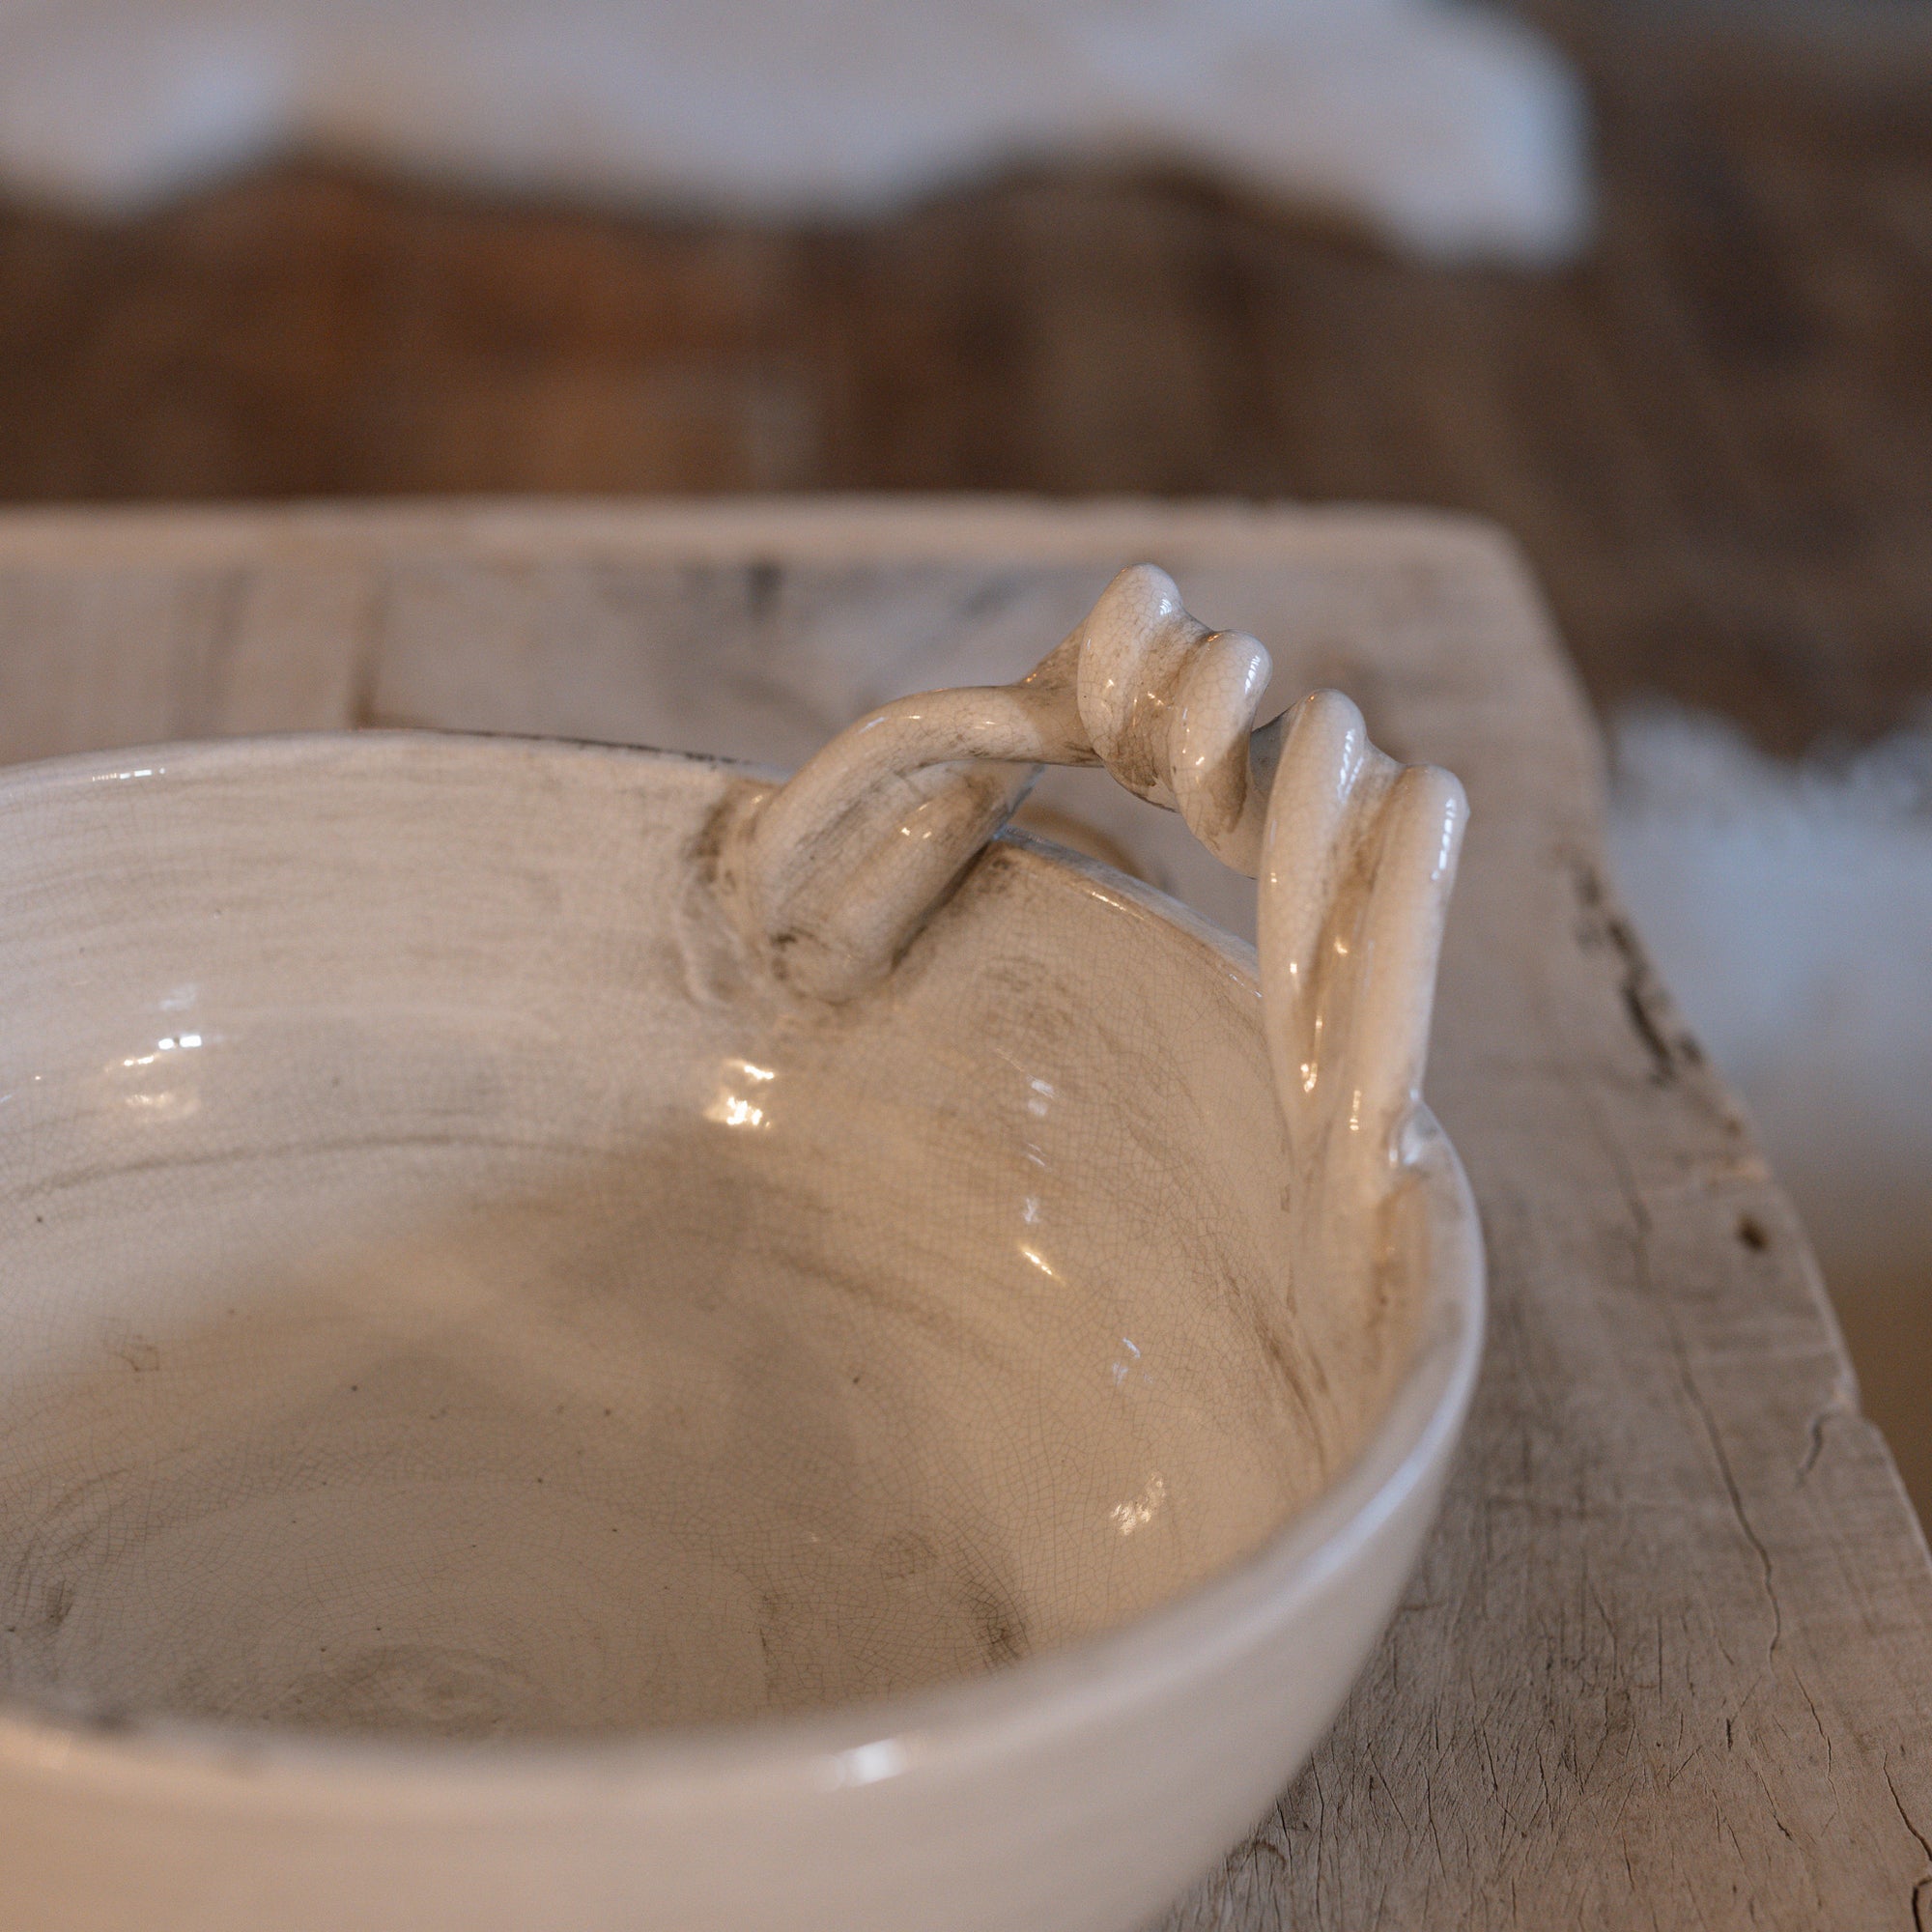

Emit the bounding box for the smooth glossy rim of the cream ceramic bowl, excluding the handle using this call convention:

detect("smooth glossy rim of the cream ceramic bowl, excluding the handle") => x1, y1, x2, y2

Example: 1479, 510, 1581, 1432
0, 728, 1488, 1810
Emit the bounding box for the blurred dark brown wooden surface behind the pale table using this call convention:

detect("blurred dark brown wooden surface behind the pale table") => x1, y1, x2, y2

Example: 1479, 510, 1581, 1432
0, 6, 1932, 750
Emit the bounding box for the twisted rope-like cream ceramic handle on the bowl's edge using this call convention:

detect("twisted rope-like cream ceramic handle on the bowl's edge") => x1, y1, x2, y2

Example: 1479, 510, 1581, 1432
719, 564, 1468, 1159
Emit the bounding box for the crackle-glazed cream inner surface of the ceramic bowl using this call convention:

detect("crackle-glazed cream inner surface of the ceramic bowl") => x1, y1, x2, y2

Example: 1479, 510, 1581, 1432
0, 734, 1424, 1737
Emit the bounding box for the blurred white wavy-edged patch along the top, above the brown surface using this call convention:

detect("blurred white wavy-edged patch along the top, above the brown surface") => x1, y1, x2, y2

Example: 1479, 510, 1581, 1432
0, 0, 1588, 261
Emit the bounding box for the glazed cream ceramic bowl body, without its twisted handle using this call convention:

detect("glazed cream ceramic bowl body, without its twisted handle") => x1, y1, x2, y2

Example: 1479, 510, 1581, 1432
0, 734, 1482, 1932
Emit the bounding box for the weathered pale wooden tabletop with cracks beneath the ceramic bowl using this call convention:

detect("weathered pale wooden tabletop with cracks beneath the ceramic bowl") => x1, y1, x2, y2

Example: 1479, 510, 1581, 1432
0, 500, 1932, 1932
